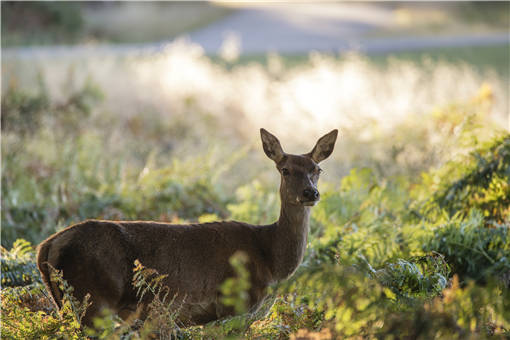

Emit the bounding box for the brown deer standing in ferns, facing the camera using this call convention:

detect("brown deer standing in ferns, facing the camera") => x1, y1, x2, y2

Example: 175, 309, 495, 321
37, 129, 338, 326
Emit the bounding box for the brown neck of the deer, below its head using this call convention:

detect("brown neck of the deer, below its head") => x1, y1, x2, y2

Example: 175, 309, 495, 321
271, 200, 310, 281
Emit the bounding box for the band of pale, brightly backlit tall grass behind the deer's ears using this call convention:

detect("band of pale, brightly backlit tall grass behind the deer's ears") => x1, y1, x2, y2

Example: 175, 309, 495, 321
2, 41, 509, 178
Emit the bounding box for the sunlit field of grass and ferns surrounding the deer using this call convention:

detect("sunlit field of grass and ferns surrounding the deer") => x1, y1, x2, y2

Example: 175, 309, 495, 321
1, 38, 510, 339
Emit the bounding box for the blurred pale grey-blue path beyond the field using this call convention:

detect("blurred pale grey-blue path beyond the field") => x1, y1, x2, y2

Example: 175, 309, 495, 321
190, 3, 509, 54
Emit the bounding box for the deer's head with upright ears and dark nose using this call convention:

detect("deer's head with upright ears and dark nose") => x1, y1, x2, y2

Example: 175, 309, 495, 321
260, 129, 338, 206
